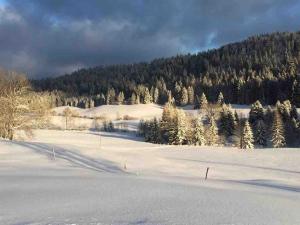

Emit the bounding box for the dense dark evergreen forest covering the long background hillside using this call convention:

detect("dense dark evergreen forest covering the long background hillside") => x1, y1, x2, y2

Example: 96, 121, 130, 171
32, 32, 300, 107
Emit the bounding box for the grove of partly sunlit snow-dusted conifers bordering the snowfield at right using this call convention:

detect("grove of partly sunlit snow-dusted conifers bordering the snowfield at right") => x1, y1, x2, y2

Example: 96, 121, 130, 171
139, 95, 300, 149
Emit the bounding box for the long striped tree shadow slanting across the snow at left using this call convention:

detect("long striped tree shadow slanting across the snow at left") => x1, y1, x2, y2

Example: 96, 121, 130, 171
15, 142, 126, 173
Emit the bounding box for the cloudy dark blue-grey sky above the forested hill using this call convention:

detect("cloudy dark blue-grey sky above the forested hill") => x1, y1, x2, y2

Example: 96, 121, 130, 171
0, 0, 300, 78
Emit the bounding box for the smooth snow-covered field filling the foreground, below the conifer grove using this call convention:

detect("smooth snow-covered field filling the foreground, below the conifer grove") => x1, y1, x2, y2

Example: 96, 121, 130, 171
0, 130, 300, 225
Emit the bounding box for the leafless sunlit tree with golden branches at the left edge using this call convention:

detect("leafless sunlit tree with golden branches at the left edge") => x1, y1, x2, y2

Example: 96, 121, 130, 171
0, 71, 50, 140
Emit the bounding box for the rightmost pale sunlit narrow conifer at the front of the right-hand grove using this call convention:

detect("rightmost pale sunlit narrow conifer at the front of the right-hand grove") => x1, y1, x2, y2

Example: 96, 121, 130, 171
272, 110, 285, 148
